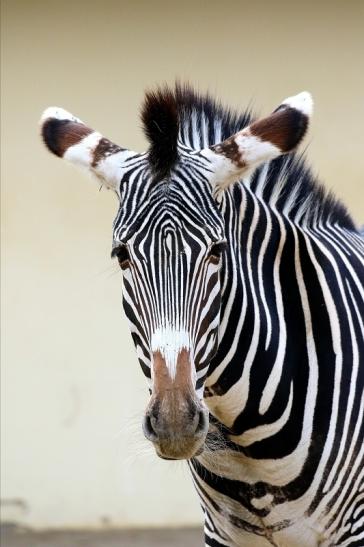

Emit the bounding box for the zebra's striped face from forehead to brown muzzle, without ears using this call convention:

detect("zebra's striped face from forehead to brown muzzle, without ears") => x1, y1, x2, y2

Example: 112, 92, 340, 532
112, 162, 224, 459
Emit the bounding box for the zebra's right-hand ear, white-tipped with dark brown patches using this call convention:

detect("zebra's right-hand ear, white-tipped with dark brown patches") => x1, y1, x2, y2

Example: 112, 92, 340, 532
201, 91, 313, 190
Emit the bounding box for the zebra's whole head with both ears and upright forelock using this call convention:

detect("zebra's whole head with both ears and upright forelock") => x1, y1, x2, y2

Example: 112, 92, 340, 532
42, 86, 311, 459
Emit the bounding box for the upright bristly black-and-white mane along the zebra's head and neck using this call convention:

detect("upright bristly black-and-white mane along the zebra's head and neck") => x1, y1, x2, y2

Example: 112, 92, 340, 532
141, 82, 356, 230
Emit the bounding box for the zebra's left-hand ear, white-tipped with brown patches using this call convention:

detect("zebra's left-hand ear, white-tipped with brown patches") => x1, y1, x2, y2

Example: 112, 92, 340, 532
40, 107, 133, 190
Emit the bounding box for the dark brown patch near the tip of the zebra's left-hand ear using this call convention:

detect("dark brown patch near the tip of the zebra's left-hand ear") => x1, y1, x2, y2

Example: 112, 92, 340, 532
42, 118, 92, 158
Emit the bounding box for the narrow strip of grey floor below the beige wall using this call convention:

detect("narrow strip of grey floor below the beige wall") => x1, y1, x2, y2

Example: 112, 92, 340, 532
1, 525, 204, 547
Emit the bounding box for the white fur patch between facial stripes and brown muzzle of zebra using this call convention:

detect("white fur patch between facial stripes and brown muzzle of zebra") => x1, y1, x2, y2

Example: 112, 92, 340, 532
151, 325, 191, 380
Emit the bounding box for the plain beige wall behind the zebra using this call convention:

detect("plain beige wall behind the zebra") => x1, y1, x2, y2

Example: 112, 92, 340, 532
1, 0, 364, 526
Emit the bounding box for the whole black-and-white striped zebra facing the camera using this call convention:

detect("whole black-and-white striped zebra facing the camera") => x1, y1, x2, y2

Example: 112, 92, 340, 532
41, 83, 364, 547
